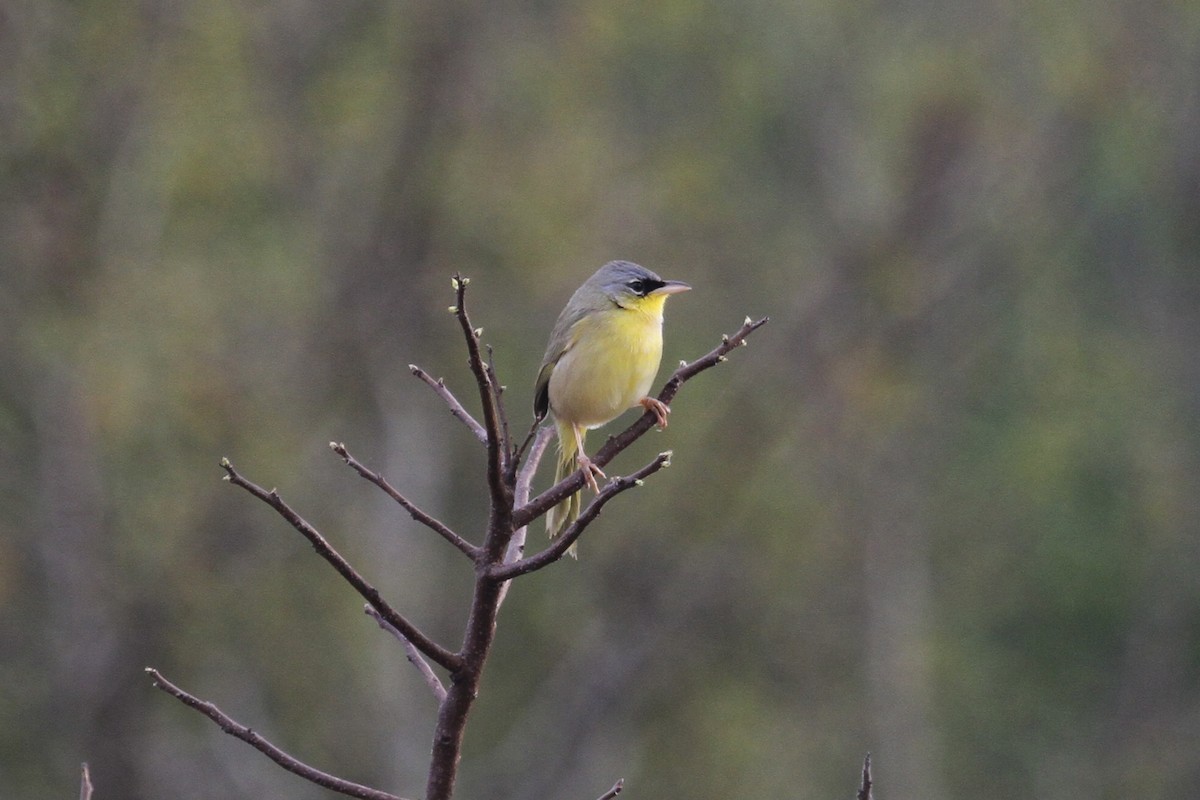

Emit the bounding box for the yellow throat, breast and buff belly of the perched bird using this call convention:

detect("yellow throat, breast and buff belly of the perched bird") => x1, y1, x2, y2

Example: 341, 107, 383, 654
550, 297, 665, 428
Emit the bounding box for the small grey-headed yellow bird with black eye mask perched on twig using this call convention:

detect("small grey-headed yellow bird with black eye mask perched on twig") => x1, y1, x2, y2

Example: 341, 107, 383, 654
534, 261, 691, 557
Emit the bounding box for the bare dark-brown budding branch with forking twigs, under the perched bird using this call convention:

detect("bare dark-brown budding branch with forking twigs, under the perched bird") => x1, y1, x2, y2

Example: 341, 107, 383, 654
146, 273, 768, 800
